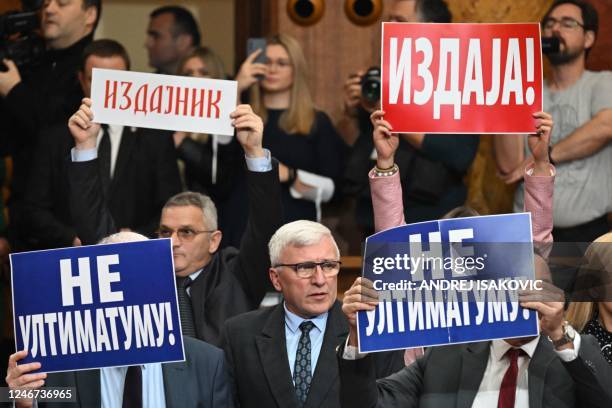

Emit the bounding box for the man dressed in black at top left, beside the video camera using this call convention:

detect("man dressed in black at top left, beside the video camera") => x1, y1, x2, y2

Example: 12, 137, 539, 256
0, 0, 101, 247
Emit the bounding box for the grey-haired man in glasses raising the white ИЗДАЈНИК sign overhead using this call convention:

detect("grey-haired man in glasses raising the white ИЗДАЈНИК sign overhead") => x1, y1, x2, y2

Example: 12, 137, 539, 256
69, 99, 281, 345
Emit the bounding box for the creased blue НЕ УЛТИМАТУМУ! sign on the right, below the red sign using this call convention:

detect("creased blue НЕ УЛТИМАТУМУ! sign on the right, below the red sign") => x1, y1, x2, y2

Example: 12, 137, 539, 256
357, 213, 541, 352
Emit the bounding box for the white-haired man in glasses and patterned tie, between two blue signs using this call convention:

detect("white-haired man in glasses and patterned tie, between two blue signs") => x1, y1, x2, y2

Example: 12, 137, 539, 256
223, 220, 404, 408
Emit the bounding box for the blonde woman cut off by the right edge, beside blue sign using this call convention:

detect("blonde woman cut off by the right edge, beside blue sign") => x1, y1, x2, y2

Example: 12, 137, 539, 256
566, 232, 612, 365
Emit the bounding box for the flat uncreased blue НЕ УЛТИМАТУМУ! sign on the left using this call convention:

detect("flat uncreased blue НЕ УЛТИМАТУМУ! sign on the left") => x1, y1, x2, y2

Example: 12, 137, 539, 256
11, 239, 185, 372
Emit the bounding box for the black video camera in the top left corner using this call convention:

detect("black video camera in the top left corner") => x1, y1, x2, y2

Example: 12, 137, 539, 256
0, 0, 45, 71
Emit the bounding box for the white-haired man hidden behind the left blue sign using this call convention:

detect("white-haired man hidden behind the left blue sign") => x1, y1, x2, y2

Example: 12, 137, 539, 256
6, 232, 233, 408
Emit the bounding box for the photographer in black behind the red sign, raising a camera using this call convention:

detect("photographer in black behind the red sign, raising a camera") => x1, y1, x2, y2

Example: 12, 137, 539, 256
337, 0, 479, 235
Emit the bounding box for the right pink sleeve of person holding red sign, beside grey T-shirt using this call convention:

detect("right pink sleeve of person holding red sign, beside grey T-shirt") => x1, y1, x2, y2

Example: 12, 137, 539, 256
524, 165, 555, 243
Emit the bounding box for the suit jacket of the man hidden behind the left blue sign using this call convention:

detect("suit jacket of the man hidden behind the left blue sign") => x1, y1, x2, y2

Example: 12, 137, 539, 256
39, 337, 233, 408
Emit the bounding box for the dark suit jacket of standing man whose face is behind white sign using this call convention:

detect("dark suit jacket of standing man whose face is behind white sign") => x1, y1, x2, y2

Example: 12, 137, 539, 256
20, 124, 181, 248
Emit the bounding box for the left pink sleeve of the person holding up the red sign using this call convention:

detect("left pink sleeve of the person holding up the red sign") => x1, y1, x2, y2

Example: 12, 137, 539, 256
369, 170, 406, 232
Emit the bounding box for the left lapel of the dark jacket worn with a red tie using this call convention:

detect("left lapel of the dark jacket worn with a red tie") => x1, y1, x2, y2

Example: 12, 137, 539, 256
457, 342, 491, 408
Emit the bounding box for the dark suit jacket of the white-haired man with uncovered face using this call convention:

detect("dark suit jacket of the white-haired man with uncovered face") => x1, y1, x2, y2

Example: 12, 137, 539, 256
222, 302, 404, 408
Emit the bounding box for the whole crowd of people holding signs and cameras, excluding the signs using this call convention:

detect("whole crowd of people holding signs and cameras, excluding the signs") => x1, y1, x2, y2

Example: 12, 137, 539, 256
0, 0, 612, 408
